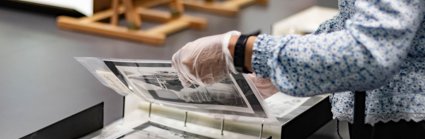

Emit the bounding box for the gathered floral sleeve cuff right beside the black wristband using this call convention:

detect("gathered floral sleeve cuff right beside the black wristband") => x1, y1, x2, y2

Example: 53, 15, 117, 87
251, 34, 276, 78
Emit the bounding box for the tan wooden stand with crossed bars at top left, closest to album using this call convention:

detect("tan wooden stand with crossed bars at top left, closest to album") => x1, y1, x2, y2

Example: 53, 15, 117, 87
57, 0, 207, 45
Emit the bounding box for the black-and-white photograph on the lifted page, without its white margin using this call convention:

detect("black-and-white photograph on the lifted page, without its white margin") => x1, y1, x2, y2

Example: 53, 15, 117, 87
105, 62, 253, 113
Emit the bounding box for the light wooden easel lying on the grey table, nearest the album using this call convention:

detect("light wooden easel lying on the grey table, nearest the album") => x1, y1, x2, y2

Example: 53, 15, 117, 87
57, 0, 207, 45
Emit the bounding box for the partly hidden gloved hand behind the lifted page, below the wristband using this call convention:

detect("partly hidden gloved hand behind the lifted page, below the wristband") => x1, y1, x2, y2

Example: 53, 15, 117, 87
247, 74, 279, 99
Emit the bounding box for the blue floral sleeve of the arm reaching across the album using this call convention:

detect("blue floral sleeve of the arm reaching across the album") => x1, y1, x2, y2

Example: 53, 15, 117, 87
252, 0, 425, 96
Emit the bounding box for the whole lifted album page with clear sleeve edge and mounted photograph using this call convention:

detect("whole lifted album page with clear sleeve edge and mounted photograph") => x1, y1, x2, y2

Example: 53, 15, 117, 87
76, 57, 270, 118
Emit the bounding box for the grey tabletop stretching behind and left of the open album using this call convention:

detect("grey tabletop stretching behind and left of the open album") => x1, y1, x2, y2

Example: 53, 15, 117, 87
0, 0, 336, 138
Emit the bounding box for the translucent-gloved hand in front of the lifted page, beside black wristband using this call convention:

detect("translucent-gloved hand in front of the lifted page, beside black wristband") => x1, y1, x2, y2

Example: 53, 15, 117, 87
172, 31, 240, 87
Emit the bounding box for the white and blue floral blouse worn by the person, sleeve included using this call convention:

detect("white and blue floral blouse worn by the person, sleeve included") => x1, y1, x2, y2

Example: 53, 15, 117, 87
252, 0, 425, 125
